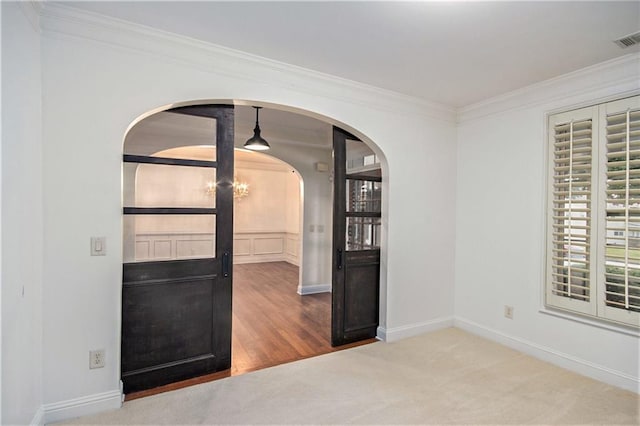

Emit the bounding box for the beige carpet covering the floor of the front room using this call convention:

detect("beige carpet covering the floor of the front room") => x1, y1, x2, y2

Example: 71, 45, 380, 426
60, 328, 640, 425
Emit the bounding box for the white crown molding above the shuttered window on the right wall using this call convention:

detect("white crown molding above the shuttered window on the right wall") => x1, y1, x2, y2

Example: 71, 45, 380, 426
458, 53, 640, 123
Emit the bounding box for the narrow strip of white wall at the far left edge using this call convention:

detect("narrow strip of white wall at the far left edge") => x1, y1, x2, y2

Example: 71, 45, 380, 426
0, 2, 43, 424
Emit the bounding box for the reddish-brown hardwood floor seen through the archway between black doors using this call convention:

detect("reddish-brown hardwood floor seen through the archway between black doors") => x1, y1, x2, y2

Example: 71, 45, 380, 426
126, 262, 376, 401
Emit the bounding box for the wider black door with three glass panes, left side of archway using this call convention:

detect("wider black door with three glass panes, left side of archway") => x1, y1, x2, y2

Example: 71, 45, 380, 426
121, 105, 234, 393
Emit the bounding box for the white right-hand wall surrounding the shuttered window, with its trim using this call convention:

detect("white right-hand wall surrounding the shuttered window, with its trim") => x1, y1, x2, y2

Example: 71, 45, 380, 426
455, 56, 640, 392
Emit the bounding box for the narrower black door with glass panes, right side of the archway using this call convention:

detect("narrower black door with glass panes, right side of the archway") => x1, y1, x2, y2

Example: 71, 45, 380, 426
331, 127, 382, 346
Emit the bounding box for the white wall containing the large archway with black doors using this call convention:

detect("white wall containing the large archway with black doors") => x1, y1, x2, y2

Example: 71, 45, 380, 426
37, 4, 456, 419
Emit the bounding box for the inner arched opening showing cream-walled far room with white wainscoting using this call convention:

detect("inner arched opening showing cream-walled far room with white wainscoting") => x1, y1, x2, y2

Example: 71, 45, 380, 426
124, 143, 303, 276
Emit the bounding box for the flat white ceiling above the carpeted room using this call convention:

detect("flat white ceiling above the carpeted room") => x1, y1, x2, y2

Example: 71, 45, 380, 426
57, 1, 640, 107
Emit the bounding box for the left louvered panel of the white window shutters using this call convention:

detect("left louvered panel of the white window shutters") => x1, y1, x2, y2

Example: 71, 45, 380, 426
547, 108, 598, 314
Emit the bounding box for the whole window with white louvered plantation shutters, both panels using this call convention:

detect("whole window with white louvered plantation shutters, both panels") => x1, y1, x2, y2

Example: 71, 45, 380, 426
545, 96, 640, 327
